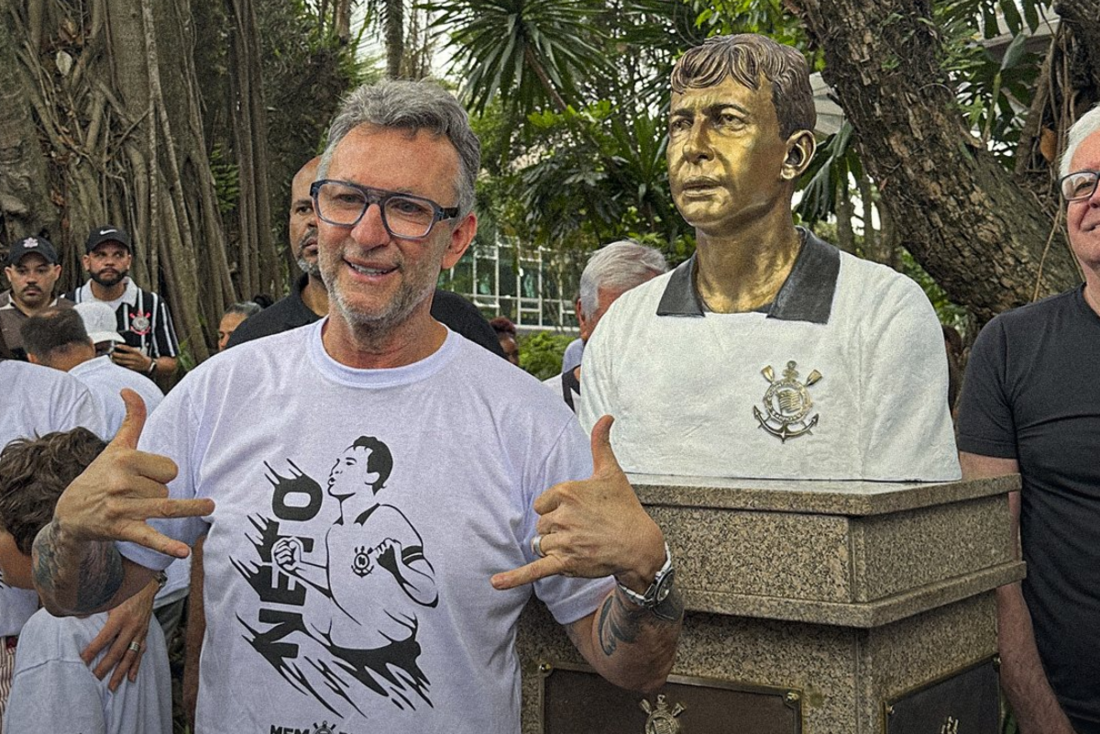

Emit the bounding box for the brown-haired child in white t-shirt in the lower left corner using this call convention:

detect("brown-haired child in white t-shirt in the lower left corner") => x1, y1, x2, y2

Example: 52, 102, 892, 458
0, 428, 172, 734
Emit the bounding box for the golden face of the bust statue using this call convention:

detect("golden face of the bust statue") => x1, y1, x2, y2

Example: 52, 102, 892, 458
668, 77, 795, 234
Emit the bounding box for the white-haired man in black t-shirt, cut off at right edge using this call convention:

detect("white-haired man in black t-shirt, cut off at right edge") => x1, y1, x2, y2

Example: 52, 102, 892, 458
958, 108, 1100, 734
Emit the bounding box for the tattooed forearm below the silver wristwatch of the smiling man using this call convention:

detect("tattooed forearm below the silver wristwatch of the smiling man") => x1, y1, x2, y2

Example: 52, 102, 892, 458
569, 588, 684, 691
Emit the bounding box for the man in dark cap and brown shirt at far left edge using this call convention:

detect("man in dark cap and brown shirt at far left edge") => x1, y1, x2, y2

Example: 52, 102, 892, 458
0, 237, 73, 361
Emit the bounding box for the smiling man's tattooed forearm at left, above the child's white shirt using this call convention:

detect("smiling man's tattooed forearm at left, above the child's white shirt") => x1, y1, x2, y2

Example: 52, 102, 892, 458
33, 519, 125, 616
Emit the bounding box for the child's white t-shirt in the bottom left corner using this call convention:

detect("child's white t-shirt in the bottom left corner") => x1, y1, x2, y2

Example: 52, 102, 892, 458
3, 610, 172, 734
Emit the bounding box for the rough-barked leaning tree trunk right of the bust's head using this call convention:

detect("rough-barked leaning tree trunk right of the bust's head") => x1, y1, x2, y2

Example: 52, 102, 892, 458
794, 0, 1079, 321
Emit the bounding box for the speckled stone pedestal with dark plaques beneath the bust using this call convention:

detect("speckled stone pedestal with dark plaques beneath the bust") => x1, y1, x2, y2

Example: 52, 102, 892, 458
519, 475, 1024, 734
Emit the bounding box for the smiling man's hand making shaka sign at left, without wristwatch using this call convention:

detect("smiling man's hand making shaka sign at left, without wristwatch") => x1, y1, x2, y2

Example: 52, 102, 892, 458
54, 390, 213, 558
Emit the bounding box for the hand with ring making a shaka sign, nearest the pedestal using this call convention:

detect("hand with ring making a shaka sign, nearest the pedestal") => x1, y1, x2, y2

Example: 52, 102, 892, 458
492, 416, 664, 593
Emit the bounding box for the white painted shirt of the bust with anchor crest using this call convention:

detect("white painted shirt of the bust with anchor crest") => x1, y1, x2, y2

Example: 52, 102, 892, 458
578, 240, 960, 481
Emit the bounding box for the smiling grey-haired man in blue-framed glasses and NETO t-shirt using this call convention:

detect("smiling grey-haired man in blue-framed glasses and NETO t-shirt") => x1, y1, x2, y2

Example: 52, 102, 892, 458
35, 81, 683, 734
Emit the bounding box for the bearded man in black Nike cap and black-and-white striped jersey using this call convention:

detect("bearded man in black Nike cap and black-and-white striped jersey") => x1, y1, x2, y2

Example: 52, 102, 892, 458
66, 224, 179, 377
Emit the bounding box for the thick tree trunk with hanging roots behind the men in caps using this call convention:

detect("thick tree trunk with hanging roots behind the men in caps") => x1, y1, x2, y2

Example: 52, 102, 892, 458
0, 0, 242, 362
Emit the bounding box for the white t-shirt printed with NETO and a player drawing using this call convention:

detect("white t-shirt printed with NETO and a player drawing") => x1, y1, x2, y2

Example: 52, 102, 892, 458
122, 321, 614, 734
